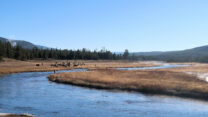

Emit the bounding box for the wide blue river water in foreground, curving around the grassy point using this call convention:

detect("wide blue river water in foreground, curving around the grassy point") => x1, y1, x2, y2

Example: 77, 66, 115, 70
0, 65, 208, 117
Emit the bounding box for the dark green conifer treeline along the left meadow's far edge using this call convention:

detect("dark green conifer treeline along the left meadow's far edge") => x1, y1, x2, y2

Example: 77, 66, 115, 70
0, 41, 126, 60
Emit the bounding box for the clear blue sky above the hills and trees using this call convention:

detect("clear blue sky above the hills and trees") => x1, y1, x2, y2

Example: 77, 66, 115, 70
0, 0, 208, 51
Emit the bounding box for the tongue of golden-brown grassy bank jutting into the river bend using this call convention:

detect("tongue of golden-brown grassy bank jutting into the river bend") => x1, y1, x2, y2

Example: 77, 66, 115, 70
49, 70, 208, 100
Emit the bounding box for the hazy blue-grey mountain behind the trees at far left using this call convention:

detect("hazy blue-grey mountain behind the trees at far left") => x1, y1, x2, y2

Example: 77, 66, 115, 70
0, 37, 50, 49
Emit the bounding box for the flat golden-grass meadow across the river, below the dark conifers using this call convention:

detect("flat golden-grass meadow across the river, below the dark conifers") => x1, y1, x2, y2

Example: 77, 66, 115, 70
0, 58, 154, 75
